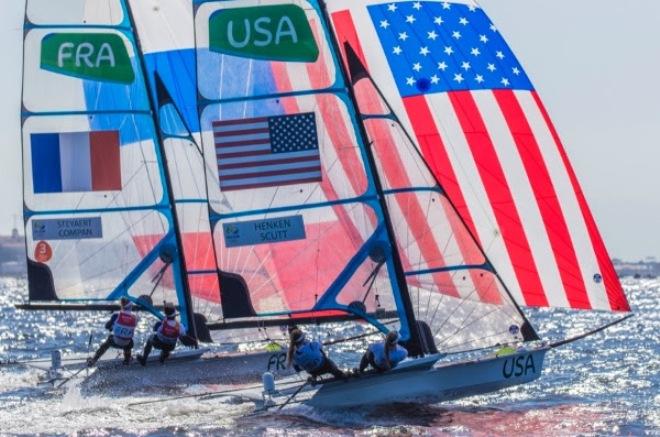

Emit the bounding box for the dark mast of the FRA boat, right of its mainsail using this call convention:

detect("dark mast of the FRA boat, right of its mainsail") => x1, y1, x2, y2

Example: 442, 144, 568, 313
124, 0, 197, 338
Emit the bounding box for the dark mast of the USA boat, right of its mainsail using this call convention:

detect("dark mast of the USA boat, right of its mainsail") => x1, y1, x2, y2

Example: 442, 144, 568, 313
318, 0, 424, 355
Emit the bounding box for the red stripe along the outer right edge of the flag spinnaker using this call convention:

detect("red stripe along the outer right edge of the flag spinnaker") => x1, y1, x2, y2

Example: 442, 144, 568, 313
531, 91, 630, 311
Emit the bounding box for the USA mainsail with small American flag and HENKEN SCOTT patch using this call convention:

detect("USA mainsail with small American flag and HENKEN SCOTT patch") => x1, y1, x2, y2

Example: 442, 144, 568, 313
195, 1, 418, 338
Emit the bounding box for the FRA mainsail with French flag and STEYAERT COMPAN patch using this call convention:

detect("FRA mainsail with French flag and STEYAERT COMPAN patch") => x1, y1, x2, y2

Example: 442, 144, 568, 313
22, 0, 195, 324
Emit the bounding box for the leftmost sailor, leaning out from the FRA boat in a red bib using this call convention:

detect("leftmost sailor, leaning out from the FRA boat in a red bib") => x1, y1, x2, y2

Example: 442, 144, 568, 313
87, 296, 138, 367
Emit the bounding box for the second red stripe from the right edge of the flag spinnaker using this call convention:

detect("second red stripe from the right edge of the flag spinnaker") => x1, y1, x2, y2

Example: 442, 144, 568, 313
493, 90, 591, 309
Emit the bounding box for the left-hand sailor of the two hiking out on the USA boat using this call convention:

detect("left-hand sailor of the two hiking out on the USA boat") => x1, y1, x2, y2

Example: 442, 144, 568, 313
287, 328, 346, 379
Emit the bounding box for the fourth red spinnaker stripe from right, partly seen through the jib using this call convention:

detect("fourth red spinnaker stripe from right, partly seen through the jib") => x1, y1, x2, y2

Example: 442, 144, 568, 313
403, 96, 501, 303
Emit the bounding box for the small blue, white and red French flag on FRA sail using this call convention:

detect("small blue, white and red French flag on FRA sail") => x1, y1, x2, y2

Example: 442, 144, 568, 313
30, 131, 121, 194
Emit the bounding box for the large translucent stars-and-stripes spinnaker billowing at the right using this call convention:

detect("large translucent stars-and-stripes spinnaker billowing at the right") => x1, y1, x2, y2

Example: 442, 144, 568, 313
329, 0, 629, 311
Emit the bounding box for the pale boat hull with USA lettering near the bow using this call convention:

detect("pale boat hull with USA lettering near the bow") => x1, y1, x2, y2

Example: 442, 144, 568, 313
304, 349, 547, 408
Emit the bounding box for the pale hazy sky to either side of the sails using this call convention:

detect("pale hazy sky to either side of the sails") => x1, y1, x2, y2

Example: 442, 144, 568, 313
0, 0, 660, 260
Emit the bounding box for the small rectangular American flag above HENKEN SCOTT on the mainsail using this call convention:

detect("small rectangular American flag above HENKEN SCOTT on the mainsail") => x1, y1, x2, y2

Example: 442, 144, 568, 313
213, 112, 321, 191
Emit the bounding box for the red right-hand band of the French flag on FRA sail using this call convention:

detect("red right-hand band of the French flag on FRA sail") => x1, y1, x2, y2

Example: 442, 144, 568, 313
89, 131, 121, 191
